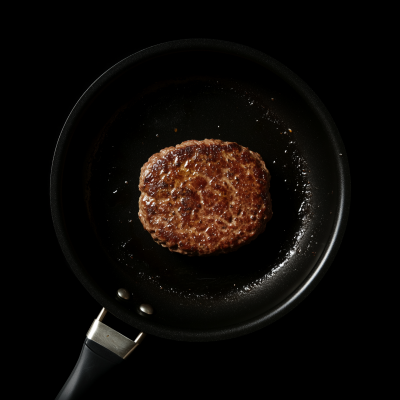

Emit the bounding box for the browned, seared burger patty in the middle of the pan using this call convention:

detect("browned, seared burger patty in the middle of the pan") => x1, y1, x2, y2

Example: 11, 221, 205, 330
139, 139, 272, 256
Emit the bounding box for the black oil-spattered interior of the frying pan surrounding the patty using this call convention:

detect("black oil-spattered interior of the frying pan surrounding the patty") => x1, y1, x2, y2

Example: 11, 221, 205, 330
64, 51, 338, 329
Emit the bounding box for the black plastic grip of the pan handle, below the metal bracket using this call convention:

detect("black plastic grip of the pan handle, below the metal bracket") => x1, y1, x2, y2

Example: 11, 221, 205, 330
56, 338, 123, 400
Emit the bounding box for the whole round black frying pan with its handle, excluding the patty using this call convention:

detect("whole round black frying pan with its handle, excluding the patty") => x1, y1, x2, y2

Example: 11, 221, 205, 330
50, 39, 350, 399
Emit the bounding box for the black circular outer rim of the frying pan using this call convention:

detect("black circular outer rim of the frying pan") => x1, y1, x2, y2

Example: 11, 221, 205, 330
50, 39, 350, 341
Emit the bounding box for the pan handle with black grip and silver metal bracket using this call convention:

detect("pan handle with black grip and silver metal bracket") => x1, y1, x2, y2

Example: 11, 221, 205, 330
56, 308, 146, 400
